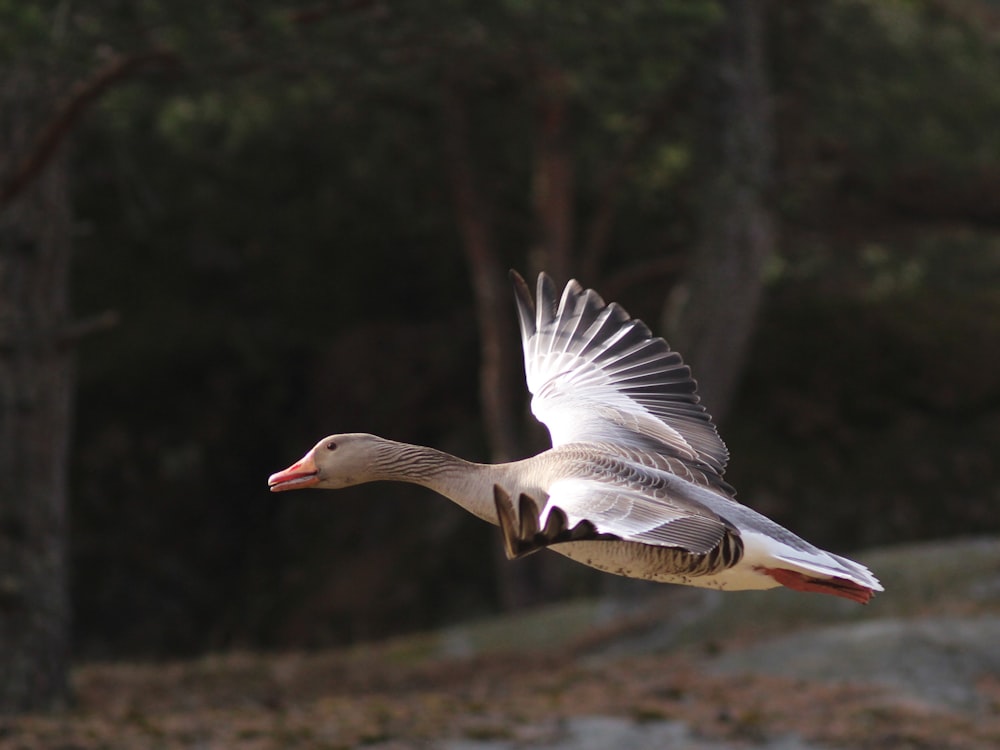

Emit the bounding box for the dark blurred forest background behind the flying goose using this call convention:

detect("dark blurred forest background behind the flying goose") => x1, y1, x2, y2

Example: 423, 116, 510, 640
0, 0, 1000, 712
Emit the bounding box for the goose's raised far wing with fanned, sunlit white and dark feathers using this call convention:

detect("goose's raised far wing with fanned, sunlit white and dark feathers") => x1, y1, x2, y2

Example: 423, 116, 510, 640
511, 271, 729, 477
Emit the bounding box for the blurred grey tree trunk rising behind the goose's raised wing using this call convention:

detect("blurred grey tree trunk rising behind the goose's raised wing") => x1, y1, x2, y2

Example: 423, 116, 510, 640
666, 0, 774, 421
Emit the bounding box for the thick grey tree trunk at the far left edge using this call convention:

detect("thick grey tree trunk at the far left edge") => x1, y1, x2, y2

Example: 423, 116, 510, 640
0, 70, 73, 714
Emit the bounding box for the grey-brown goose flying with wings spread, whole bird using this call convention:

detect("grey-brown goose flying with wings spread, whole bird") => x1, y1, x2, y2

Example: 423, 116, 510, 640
268, 272, 882, 603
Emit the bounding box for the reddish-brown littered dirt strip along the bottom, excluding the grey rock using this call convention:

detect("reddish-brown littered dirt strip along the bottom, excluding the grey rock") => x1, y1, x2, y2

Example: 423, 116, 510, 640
0, 624, 1000, 750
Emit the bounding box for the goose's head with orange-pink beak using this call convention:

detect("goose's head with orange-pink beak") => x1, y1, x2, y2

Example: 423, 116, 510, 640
267, 433, 386, 492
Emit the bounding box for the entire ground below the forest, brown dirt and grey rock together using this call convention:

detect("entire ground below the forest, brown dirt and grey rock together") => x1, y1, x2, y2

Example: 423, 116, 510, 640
0, 539, 1000, 750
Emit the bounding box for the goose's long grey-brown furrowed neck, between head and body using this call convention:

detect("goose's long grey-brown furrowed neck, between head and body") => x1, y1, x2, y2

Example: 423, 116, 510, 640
371, 440, 513, 524
